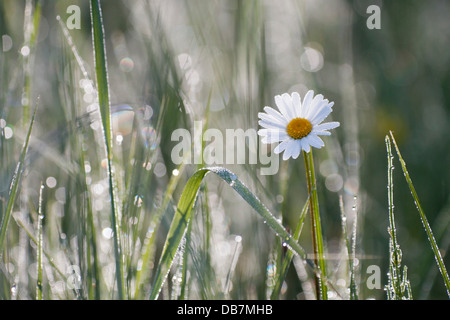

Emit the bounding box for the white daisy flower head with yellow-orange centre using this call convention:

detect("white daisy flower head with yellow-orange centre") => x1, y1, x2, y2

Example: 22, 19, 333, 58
258, 90, 339, 160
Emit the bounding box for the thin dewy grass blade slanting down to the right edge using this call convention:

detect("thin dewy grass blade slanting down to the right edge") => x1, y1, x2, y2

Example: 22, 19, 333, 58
389, 131, 450, 297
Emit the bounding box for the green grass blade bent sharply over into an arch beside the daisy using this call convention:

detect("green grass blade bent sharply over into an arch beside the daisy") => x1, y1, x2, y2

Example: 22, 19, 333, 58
150, 167, 332, 299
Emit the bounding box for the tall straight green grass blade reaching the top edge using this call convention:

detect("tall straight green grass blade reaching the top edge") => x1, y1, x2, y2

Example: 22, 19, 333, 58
91, 0, 125, 299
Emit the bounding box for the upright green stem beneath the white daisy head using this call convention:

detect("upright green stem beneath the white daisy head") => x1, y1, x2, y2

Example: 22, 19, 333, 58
303, 151, 328, 300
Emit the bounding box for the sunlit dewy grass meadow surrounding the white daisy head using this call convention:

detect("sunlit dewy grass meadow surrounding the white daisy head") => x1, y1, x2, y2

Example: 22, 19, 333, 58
0, 0, 450, 300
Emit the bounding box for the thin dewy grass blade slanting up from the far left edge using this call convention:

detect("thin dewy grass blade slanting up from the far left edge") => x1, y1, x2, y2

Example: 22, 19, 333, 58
0, 100, 39, 255
